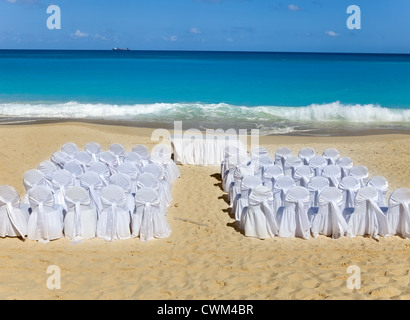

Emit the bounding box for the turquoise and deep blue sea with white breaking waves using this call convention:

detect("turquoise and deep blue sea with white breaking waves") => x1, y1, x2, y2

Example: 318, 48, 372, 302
0, 50, 410, 134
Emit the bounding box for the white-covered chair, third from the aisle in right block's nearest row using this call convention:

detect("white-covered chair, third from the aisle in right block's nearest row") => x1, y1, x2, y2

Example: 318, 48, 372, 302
311, 187, 347, 239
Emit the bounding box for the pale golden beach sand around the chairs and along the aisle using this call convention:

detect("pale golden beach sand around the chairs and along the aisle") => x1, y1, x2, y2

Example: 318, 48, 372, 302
0, 122, 410, 300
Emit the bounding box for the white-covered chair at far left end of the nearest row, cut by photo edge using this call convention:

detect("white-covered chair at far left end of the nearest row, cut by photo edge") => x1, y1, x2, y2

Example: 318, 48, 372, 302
0, 185, 29, 240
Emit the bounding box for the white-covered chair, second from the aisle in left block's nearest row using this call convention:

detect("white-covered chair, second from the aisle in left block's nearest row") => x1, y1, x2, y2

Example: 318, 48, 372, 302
97, 185, 131, 241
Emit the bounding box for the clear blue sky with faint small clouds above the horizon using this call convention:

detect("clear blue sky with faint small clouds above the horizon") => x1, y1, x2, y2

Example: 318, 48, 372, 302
0, 0, 410, 53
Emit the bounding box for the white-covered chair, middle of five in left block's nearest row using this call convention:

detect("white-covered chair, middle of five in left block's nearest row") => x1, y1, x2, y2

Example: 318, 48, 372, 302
64, 187, 97, 244
